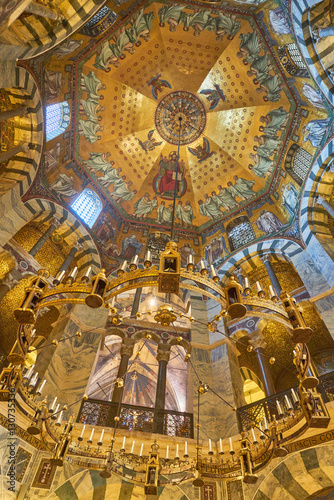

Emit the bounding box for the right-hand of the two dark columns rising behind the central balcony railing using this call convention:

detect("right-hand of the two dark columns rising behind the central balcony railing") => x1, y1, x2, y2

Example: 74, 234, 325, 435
154, 344, 170, 434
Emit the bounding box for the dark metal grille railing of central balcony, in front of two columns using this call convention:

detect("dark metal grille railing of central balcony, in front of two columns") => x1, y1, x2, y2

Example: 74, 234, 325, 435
77, 399, 194, 438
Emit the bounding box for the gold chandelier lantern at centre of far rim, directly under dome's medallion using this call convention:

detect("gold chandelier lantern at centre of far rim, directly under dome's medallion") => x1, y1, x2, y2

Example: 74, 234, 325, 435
158, 241, 181, 293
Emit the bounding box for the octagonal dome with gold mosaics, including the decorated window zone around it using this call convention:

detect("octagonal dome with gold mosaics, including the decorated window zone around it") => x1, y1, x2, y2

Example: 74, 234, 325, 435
25, 0, 333, 272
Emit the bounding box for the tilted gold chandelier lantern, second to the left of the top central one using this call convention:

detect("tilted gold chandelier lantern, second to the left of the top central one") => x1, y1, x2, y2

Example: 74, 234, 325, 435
14, 269, 49, 325
